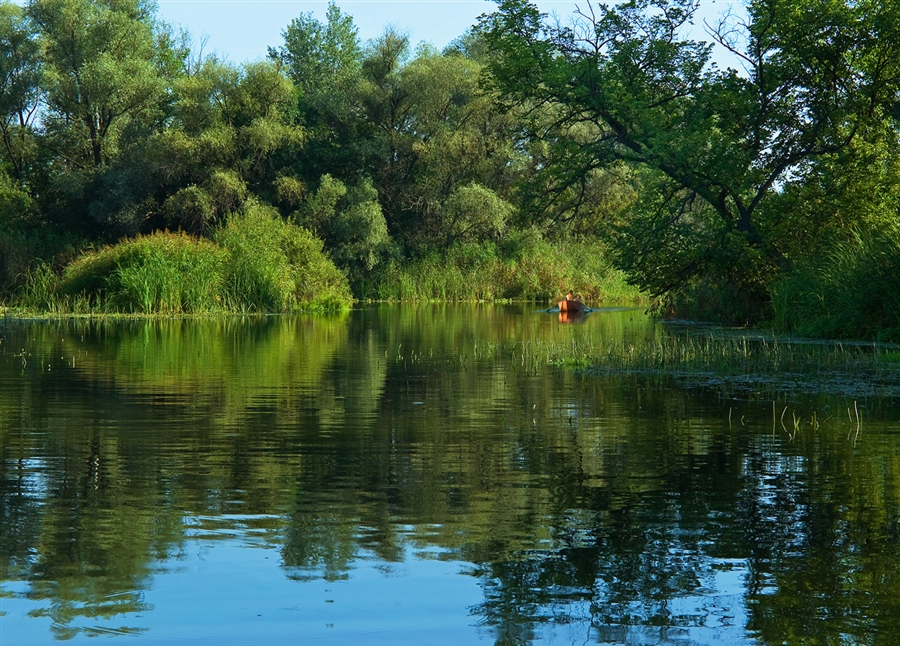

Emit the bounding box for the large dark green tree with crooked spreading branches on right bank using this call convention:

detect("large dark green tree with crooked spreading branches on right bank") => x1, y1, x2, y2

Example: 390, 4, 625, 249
480, 0, 900, 318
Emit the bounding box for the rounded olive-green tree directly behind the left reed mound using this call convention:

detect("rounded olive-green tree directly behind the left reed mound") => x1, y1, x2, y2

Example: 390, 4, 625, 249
130, 58, 305, 234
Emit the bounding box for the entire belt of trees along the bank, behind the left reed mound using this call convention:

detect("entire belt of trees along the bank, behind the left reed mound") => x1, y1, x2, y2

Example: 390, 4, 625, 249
0, 0, 900, 338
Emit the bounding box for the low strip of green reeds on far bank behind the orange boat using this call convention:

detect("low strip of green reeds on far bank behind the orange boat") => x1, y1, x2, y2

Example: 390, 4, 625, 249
376, 232, 646, 305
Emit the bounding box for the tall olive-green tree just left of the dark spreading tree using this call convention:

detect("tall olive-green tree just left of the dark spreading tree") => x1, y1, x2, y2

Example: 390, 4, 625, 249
397, 48, 518, 247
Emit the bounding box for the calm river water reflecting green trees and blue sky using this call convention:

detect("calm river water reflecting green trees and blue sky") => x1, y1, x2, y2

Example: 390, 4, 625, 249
0, 305, 900, 646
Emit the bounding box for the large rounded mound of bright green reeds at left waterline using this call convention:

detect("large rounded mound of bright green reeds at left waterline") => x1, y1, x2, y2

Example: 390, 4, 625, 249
17, 206, 351, 315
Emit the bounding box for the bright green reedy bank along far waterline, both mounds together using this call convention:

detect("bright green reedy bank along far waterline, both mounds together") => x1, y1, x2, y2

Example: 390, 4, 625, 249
8, 224, 646, 315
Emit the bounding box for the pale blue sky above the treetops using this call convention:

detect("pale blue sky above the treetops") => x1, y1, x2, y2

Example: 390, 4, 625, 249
157, 0, 741, 63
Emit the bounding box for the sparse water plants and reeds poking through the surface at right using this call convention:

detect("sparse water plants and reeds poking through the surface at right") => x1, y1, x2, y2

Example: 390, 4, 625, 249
386, 335, 900, 400
